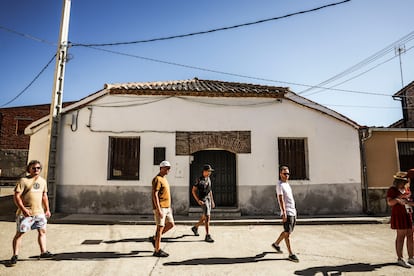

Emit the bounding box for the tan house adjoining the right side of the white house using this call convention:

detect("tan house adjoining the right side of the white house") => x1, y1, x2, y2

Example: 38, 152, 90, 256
361, 82, 414, 214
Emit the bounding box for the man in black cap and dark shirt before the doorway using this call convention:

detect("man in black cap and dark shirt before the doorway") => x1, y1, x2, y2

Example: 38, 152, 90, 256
191, 164, 215, 242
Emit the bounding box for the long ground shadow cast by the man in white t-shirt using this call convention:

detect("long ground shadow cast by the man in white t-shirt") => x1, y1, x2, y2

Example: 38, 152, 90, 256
164, 252, 288, 266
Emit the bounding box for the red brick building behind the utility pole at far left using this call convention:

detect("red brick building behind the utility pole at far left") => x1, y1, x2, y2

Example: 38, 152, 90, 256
0, 103, 70, 185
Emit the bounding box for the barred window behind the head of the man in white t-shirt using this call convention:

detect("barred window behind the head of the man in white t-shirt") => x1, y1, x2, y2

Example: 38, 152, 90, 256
278, 138, 309, 180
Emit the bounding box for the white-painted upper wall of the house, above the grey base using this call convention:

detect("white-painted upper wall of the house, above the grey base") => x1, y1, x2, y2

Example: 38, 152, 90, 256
29, 95, 361, 216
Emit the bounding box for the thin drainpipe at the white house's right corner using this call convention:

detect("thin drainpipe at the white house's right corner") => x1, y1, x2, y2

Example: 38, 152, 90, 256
358, 127, 372, 215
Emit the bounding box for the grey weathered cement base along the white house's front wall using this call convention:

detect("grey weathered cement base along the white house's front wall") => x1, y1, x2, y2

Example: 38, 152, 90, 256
56, 183, 362, 216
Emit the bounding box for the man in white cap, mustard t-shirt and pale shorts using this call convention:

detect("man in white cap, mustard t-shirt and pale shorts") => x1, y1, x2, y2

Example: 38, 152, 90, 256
150, 161, 174, 257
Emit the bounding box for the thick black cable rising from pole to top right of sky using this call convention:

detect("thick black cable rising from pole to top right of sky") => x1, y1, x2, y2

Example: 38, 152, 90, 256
72, 0, 351, 47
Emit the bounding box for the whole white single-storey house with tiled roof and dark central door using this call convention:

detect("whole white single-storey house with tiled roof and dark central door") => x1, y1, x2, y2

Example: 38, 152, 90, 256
26, 78, 362, 215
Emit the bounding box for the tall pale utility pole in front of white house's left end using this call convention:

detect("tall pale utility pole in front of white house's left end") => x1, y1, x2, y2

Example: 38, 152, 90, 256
44, 0, 71, 212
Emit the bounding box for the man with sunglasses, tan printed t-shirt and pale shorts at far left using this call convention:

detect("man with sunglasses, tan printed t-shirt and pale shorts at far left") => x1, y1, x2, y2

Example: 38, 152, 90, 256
10, 160, 53, 266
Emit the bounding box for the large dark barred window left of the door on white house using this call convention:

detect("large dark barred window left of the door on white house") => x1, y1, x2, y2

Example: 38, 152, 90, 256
108, 137, 140, 180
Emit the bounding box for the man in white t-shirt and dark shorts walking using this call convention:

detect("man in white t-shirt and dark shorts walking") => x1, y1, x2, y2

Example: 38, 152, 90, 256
272, 166, 299, 262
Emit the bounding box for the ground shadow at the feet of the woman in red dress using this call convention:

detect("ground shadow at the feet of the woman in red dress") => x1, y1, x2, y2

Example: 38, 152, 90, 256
295, 263, 397, 276
